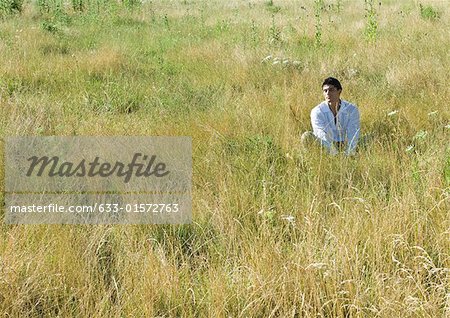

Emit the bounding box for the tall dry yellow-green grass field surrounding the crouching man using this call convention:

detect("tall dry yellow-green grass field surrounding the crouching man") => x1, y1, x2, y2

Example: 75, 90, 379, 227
0, 0, 450, 318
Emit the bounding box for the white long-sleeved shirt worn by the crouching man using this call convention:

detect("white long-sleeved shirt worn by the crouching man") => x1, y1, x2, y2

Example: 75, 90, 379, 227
311, 100, 360, 155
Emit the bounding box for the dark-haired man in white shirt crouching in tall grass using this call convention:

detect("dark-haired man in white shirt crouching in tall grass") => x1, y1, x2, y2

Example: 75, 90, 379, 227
301, 77, 360, 155
